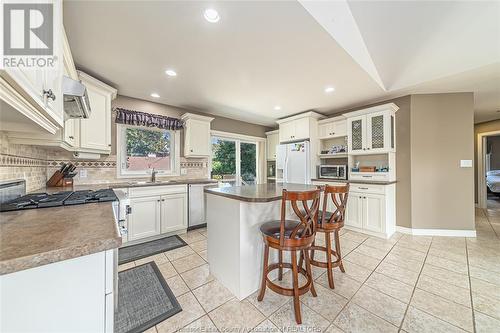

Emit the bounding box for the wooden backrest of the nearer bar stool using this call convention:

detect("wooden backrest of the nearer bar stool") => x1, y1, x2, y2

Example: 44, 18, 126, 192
280, 188, 321, 246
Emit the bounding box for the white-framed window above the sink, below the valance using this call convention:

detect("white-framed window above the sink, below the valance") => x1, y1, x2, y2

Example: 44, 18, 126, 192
117, 125, 179, 177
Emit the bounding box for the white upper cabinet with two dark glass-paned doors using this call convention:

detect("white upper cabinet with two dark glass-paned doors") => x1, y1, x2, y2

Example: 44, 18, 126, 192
345, 103, 398, 154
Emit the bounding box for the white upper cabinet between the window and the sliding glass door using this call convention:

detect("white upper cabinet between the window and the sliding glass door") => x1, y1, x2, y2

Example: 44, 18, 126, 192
181, 113, 214, 157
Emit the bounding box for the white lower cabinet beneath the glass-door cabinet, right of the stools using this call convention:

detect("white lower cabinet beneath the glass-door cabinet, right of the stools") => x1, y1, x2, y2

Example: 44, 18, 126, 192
313, 181, 396, 238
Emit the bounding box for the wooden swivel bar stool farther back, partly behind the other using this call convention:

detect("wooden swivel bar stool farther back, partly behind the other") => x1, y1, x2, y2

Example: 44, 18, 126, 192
299, 184, 349, 289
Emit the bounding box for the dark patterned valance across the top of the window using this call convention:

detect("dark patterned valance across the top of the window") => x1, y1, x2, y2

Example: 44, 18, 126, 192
114, 108, 183, 130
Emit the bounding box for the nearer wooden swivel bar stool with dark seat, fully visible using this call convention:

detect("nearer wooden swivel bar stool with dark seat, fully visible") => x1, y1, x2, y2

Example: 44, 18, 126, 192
257, 188, 320, 324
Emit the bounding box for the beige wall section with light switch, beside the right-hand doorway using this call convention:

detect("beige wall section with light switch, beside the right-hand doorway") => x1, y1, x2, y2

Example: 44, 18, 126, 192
410, 93, 475, 230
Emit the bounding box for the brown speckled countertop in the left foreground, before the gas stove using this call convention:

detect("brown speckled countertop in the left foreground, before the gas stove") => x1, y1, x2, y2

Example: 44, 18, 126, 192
0, 202, 121, 275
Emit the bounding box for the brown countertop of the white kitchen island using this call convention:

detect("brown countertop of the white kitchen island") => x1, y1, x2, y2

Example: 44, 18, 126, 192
205, 184, 318, 202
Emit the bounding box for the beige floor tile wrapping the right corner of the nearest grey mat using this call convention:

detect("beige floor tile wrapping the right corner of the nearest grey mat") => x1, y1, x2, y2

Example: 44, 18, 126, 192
156, 293, 205, 333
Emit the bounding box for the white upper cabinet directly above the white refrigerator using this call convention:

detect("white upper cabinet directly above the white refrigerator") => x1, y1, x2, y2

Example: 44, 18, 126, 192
277, 111, 321, 142
